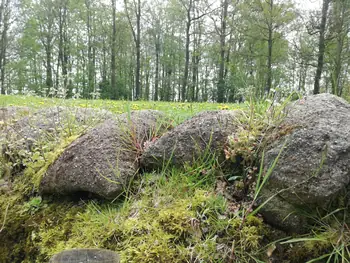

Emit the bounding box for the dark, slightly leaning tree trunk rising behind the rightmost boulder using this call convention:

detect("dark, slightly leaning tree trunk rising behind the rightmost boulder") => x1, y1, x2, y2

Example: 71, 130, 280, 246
313, 0, 331, 94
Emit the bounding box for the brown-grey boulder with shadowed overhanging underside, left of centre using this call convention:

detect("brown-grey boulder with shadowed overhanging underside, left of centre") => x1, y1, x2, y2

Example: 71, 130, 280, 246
40, 110, 163, 199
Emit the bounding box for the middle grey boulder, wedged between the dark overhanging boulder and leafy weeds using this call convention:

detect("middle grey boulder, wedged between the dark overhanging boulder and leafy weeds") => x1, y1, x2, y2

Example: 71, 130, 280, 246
141, 111, 240, 171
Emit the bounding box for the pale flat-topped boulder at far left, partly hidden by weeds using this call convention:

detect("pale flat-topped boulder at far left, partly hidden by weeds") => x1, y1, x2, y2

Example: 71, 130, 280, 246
0, 107, 114, 174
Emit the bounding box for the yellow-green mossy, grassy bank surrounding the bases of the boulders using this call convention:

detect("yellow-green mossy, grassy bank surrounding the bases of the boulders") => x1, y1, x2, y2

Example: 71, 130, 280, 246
0, 100, 350, 263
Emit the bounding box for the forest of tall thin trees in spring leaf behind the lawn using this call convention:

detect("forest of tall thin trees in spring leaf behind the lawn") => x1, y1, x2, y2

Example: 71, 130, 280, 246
0, 0, 350, 103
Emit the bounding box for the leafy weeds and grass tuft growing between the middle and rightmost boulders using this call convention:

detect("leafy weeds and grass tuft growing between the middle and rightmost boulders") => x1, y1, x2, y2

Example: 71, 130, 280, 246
224, 94, 293, 191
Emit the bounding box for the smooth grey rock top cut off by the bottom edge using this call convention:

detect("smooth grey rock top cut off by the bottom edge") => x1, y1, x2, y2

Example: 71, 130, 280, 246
49, 248, 120, 263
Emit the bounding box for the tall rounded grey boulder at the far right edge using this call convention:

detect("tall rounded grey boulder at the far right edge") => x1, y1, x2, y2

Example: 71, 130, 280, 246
261, 94, 350, 232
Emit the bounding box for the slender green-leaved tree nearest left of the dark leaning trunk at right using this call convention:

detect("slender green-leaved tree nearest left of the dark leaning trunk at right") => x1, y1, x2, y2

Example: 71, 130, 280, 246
241, 0, 295, 97
